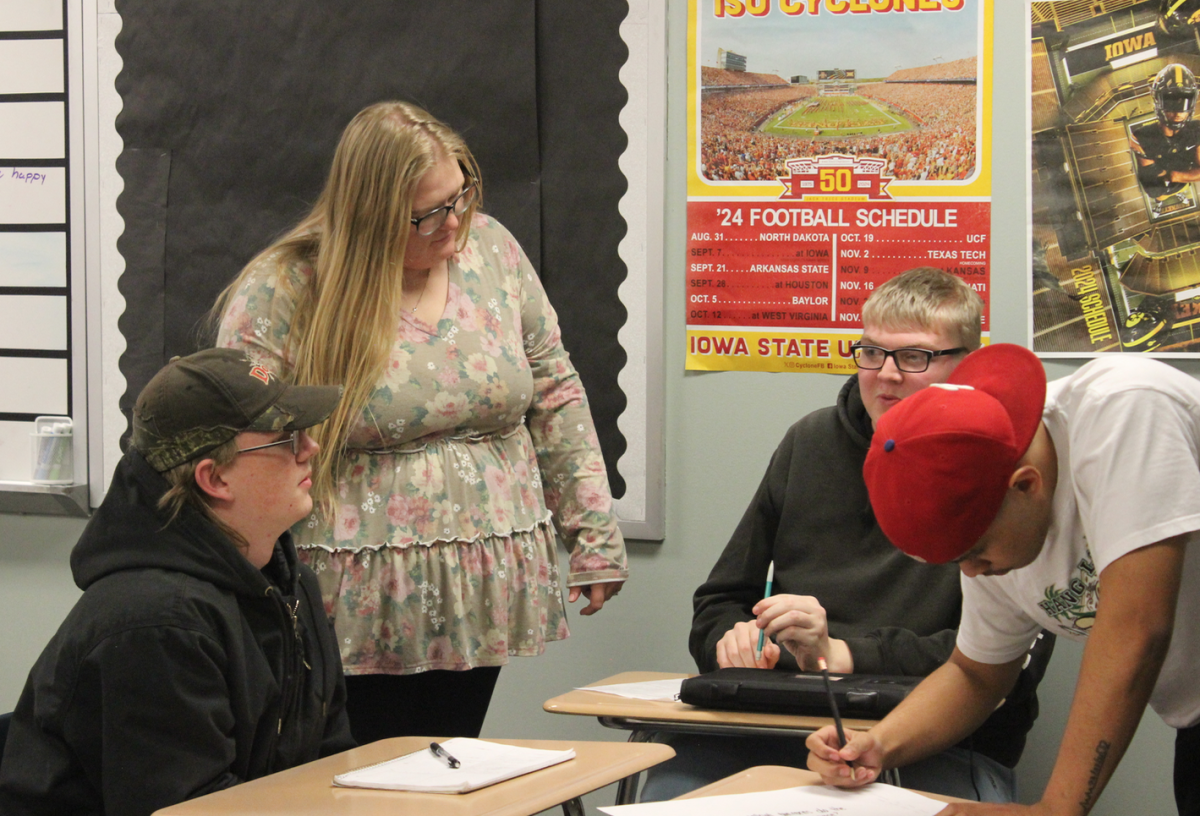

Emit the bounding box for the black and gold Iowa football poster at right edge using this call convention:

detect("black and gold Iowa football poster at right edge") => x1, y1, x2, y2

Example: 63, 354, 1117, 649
1030, 0, 1200, 358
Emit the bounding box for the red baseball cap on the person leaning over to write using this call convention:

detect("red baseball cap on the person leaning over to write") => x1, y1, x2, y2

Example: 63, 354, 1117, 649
863, 343, 1046, 564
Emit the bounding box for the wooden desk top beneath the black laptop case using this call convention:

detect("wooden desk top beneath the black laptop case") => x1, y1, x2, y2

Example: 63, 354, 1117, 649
542, 672, 876, 733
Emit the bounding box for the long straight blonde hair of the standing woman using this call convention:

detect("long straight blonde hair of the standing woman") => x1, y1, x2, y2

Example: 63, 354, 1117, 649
214, 102, 482, 515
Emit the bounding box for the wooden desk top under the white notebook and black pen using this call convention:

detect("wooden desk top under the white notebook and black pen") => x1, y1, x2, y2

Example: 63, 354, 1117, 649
155, 737, 674, 816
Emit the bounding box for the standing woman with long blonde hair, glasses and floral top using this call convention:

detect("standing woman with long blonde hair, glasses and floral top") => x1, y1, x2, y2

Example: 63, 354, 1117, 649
216, 102, 629, 743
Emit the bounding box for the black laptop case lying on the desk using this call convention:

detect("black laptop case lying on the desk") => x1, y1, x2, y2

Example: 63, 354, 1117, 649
679, 668, 924, 720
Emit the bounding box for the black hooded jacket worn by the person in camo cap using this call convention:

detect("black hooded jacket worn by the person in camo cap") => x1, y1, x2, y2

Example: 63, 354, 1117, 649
0, 451, 354, 816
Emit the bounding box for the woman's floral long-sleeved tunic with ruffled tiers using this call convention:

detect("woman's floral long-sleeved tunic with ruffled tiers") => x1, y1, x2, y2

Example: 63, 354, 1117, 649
217, 215, 629, 674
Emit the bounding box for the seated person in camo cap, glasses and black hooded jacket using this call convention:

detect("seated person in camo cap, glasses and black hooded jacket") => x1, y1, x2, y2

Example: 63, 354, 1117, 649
0, 349, 354, 816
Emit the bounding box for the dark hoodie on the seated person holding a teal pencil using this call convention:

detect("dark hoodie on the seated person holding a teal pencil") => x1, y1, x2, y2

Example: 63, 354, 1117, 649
689, 377, 1054, 768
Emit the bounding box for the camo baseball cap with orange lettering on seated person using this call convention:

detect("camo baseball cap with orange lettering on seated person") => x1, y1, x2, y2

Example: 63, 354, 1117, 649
133, 348, 342, 473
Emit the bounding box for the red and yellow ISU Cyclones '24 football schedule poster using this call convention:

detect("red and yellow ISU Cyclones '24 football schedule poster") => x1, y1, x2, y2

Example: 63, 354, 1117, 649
686, 0, 991, 373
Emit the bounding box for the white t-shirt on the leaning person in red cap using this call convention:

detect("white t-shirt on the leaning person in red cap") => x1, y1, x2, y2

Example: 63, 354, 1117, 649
958, 356, 1200, 728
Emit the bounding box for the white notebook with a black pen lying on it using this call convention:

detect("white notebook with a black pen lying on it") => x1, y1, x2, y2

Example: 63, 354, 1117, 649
334, 737, 575, 793
